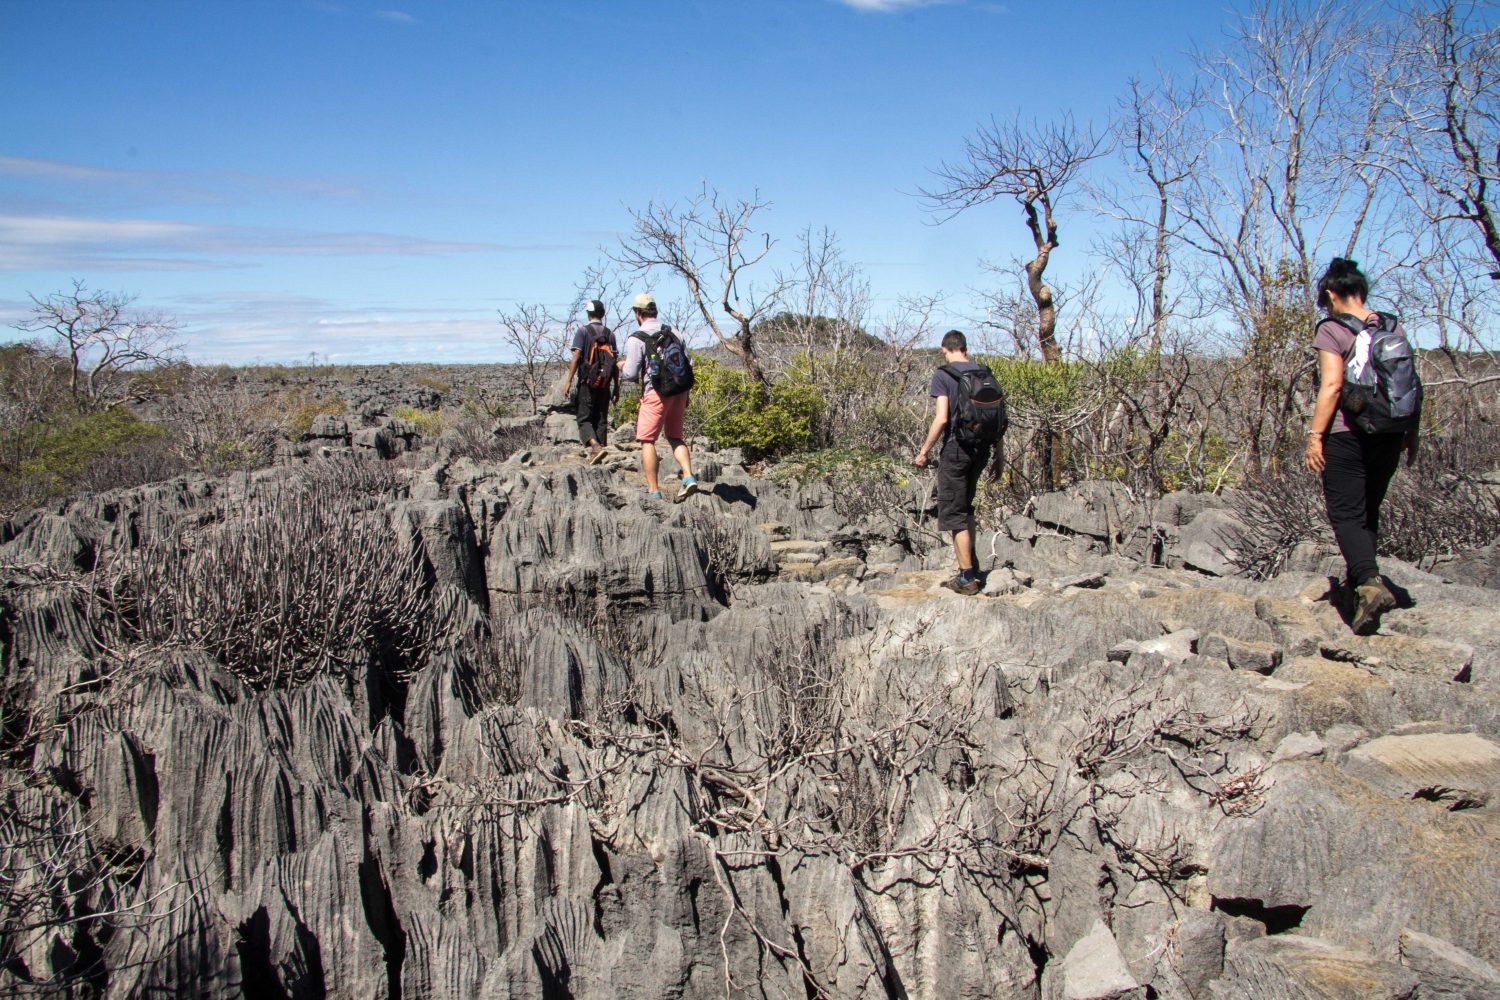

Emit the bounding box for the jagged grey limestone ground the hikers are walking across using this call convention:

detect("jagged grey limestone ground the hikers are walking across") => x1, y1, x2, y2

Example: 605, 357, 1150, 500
0, 418, 1500, 1000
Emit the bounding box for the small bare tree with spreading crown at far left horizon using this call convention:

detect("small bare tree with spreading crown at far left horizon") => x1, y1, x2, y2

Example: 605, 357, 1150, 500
17, 280, 182, 409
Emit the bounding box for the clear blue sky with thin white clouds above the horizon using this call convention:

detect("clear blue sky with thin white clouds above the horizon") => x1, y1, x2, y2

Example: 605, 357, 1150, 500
0, 0, 1232, 363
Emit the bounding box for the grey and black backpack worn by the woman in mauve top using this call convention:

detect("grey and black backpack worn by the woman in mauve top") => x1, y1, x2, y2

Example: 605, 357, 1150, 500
1329, 312, 1422, 433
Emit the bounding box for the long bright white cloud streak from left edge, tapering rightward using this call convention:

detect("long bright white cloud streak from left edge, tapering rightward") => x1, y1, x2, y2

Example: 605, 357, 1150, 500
0, 214, 581, 270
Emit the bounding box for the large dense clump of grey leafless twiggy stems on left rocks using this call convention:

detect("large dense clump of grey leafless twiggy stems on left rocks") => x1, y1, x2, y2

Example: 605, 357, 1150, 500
96, 462, 438, 688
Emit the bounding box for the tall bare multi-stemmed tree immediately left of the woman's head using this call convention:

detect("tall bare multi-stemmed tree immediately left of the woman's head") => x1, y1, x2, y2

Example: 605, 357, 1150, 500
1179, 0, 1391, 471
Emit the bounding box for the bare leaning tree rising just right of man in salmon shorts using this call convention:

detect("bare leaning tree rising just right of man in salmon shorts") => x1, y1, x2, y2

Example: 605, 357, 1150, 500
611, 184, 782, 385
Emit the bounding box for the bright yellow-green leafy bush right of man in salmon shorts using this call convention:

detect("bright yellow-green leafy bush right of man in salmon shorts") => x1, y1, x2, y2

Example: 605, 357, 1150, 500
689, 358, 824, 459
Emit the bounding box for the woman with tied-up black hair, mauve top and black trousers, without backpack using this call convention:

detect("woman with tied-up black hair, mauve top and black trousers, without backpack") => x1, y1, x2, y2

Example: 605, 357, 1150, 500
1307, 256, 1418, 636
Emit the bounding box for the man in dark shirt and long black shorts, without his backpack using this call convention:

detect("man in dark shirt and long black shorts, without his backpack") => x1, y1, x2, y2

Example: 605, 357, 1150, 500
914, 330, 990, 595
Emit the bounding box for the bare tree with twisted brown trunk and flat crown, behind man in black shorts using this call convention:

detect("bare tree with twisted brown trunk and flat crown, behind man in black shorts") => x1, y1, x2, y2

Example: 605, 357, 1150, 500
923, 117, 1104, 361
